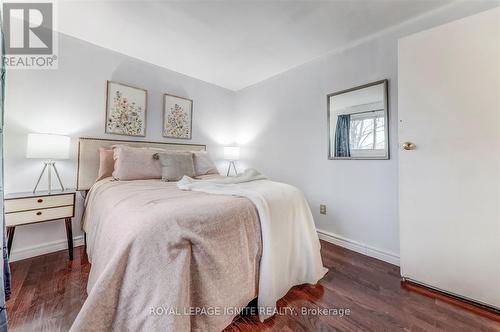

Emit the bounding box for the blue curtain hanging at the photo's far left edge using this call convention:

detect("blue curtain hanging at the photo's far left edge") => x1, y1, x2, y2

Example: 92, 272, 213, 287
0, 11, 10, 332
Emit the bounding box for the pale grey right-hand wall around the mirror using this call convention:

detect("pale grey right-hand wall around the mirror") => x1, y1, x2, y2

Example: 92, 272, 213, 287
232, 2, 495, 263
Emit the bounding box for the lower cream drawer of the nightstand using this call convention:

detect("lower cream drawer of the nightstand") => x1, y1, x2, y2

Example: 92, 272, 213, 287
5, 205, 73, 226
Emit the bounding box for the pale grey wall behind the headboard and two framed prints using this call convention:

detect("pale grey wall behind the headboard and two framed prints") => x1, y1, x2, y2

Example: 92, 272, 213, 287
5, 34, 234, 260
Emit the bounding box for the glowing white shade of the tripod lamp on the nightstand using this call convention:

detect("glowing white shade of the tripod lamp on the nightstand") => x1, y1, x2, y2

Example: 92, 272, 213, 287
26, 134, 70, 159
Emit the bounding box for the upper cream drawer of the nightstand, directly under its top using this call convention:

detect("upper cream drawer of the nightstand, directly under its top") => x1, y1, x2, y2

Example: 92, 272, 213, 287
4, 193, 75, 213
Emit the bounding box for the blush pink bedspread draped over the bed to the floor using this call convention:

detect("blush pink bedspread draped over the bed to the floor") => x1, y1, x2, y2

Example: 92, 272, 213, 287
71, 179, 262, 331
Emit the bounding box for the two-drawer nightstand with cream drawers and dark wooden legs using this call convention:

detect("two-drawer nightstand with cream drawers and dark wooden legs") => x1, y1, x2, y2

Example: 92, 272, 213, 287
4, 189, 76, 260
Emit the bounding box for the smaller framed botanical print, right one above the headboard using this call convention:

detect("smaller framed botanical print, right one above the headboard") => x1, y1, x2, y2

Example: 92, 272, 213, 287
163, 94, 193, 139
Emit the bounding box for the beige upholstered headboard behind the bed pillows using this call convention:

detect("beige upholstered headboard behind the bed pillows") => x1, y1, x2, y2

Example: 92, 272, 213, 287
76, 137, 207, 190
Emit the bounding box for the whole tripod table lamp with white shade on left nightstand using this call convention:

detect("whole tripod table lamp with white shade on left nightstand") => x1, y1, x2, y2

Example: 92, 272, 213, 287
26, 134, 70, 194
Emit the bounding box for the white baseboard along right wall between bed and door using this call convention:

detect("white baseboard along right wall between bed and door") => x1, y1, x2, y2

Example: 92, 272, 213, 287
317, 229, 399, 266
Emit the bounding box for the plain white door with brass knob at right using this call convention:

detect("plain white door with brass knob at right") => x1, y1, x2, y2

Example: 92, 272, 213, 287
398, 8, 500, 308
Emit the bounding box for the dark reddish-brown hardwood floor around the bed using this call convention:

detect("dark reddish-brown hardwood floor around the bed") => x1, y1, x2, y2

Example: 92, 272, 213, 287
7, 241, 500, 332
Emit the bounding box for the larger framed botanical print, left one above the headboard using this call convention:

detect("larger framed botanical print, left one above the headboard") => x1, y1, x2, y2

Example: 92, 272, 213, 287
106, 81, 148, 137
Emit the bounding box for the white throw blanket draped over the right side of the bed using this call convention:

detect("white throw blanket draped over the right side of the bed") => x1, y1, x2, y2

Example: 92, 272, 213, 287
177, 169, 328, 321
